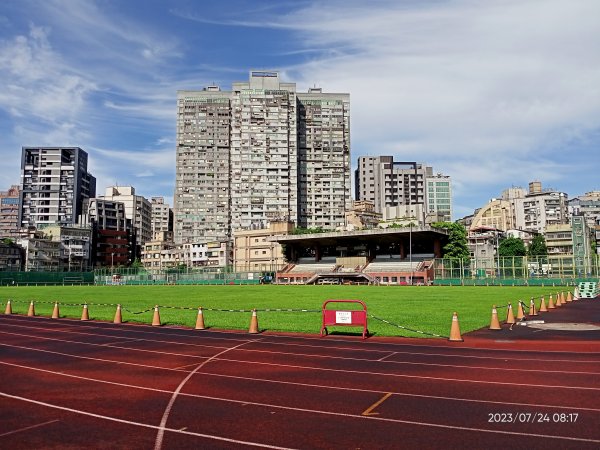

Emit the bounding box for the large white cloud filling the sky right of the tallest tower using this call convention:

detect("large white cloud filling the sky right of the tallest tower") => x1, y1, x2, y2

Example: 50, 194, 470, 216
286, 0, 600, 202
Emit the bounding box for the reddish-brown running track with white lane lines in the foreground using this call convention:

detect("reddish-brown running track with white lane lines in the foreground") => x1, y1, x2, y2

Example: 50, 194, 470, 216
0, 300, 600, 449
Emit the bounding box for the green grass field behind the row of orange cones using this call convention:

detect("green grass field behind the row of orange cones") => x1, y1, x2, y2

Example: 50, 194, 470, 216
0, 285, 563, 337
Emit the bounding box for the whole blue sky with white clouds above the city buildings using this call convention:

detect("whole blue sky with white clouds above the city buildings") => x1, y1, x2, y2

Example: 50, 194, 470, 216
0, 0, 600, 218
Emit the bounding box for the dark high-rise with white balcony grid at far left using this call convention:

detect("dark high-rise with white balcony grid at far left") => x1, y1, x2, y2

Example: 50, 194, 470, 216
19, 147, 96, 228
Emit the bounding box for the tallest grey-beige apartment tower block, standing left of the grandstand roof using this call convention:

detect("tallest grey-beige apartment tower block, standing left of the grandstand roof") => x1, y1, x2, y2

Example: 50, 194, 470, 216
174, 71, 351, 243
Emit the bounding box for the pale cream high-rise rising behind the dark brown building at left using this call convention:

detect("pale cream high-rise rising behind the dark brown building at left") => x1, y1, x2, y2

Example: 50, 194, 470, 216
98, 186, 152, 253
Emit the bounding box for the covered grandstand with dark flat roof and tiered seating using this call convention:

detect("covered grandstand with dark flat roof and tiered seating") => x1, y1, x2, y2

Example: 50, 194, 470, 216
270, 226, 448, 285
